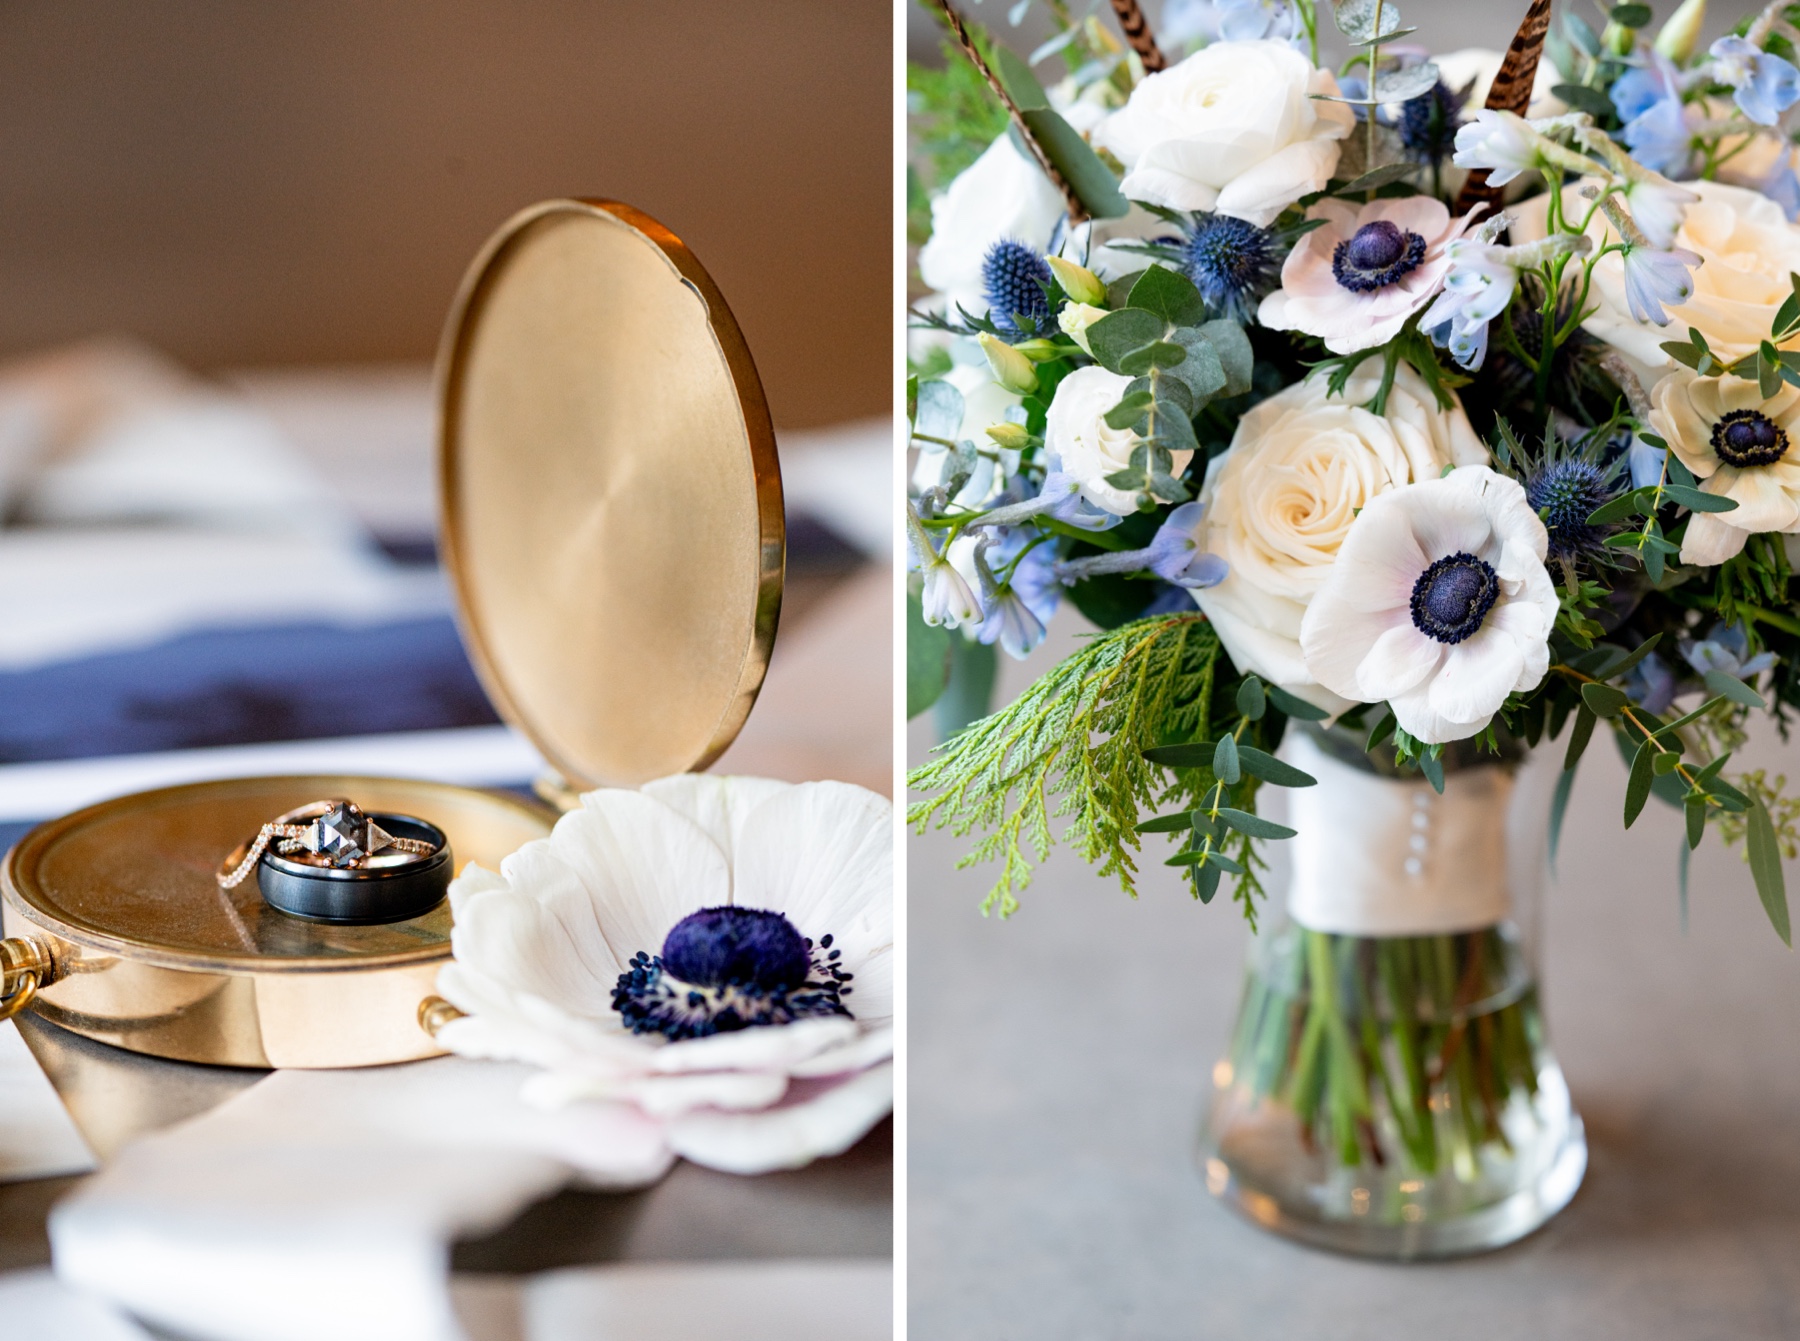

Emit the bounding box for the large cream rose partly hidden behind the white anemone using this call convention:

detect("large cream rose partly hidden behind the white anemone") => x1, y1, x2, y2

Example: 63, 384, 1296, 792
1193, 364, 1489, 713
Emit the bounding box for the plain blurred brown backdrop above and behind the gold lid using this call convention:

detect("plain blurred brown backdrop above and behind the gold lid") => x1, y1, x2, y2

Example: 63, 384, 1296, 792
0, 0, 893, 427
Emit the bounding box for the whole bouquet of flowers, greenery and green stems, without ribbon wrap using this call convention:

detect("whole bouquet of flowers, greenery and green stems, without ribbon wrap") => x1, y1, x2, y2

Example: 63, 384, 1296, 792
905, 0, 1800, 1238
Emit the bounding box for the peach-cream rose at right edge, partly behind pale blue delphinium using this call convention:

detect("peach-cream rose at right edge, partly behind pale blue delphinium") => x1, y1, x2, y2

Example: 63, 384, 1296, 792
1512, 182, 1800, 385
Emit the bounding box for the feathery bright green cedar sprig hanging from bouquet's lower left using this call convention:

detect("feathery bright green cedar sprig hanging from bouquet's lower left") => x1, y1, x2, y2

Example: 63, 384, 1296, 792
907, 612, 1255, 916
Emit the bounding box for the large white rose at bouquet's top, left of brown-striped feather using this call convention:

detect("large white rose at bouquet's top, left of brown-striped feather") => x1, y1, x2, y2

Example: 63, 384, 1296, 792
1094, 41, 1355, 225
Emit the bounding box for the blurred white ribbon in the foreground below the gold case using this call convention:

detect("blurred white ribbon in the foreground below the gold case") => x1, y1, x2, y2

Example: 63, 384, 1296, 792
50, 1058, 673, 1341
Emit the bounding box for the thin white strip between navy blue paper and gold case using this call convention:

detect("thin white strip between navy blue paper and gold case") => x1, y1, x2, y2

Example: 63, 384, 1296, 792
0, 725, 545, 821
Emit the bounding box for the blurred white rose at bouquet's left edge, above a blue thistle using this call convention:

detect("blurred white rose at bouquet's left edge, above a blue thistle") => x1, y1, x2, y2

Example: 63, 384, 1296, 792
918, 135, 1066, 320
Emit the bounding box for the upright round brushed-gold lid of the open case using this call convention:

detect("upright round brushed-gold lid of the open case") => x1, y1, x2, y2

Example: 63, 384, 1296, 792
437, 200, 785, 788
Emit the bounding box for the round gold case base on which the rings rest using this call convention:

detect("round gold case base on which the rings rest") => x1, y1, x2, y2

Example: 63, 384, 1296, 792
0, 776, 554, 1067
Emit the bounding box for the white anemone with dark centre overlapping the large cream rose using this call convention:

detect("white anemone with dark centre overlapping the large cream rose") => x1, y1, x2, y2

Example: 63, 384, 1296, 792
1300, 466, 1557, 745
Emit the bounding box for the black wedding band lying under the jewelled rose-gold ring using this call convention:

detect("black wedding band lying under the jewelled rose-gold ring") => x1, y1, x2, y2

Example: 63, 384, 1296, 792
256, 812, 452, 922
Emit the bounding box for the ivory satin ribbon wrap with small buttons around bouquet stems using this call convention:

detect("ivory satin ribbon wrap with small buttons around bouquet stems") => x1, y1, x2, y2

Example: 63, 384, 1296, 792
1282, 731, 1548, 936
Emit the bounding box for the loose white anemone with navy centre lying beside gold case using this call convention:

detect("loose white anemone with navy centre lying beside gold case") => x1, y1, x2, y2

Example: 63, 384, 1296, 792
437, 774, 893, 1174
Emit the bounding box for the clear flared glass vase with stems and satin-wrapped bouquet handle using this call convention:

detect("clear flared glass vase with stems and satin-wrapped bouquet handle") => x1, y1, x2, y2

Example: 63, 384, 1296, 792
1201, 729, 1588, 1258
